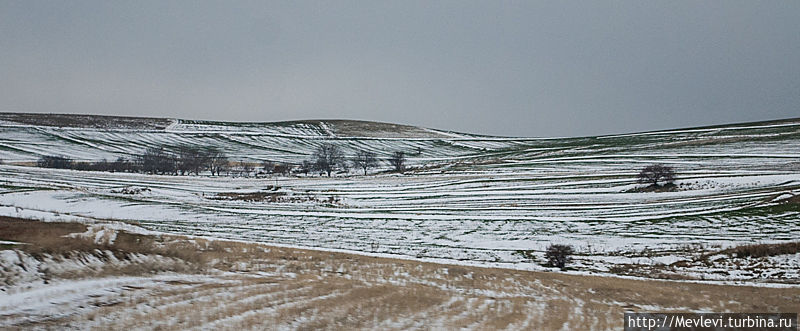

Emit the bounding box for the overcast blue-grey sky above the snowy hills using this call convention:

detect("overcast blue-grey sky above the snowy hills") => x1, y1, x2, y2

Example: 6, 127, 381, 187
0, 0, 800, 136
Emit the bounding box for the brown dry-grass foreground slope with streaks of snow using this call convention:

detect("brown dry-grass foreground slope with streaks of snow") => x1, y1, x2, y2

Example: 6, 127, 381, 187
0, 218, 800, 330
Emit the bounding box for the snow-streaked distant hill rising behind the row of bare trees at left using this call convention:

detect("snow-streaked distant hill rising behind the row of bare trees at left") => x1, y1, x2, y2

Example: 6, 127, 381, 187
0, 113, 524, 163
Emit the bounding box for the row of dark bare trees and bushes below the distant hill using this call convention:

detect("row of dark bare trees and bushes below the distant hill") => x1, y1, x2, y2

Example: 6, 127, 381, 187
36, 144, 406, 177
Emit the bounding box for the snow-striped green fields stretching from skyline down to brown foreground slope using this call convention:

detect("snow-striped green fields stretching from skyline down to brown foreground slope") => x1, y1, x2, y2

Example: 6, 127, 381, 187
0, 116, 800, 282
